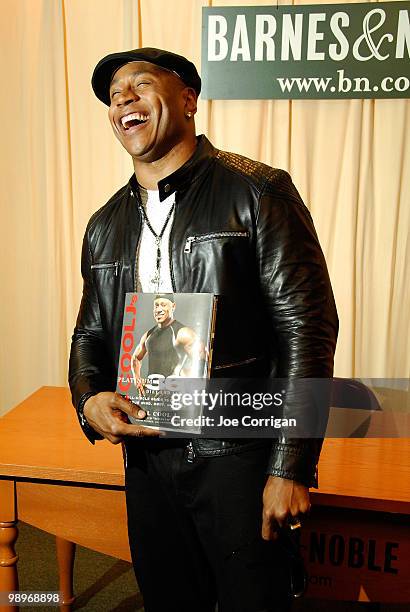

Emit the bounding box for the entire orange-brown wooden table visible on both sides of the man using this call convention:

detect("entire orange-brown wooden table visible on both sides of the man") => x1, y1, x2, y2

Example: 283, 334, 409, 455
0, 387, 410, 611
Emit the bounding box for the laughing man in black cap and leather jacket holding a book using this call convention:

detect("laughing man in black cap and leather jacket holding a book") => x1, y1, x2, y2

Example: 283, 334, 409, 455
69, 48, 338, 612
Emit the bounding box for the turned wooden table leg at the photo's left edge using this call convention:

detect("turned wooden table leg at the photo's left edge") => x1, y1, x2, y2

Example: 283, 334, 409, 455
0, 480, 18, 612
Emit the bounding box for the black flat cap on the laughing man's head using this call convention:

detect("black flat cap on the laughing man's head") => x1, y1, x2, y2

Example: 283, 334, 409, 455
91, 47, 201, 106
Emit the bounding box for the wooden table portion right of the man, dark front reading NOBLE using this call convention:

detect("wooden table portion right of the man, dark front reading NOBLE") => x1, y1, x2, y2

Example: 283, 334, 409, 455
302, 438, 410, 603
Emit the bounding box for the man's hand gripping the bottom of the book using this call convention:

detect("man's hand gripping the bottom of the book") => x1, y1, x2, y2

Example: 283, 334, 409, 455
84, 391, 161, 444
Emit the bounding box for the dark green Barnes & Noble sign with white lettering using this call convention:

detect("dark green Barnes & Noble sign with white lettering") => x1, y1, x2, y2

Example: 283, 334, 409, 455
202, 2, 410, 100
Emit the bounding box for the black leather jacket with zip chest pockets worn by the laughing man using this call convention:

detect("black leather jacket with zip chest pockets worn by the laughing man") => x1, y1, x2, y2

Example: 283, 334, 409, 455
69, 136, 338, 486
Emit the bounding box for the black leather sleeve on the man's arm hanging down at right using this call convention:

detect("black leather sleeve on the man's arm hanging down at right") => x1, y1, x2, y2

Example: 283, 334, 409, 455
256, 170, 338, 486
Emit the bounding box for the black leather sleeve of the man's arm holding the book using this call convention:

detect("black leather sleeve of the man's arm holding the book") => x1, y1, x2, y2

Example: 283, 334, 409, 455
68, 225, 106, 443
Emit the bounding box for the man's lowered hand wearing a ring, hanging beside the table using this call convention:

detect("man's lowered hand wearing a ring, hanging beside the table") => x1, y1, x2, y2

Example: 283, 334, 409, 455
262, 476, 310, 540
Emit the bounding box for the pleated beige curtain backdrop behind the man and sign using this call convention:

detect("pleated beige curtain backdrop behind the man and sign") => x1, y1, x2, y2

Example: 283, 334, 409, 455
0, 0, 410, 414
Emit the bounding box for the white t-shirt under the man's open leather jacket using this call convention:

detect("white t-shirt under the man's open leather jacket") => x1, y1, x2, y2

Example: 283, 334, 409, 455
137, 187, 175, 293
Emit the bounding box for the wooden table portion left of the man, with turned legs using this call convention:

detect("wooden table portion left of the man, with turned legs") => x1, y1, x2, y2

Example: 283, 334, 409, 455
0, 387, 130, 611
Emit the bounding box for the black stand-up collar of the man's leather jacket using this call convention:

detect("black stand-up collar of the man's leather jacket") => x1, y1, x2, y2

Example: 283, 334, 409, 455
129, 134, 218, 202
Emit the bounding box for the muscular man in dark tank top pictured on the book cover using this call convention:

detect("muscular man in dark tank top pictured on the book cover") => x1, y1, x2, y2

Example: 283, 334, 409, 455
131, 293, 206, 393
